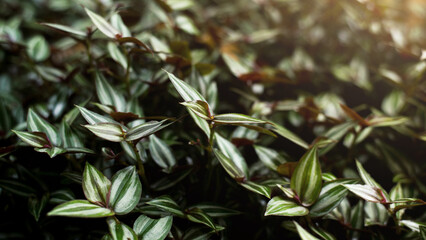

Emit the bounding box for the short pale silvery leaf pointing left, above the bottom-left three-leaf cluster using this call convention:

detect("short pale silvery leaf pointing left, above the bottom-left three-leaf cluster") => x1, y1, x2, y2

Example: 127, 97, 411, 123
84, 123, 125, 142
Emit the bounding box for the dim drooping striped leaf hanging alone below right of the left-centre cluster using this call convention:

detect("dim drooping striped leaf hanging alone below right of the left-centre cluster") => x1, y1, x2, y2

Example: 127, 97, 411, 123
149, 134, 176, 172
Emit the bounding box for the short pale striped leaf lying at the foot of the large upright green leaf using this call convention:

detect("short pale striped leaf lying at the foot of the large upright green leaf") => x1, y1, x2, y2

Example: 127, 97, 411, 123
265, 197, 309, 217
